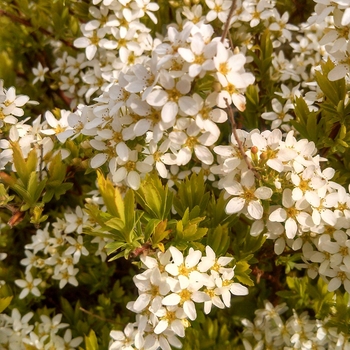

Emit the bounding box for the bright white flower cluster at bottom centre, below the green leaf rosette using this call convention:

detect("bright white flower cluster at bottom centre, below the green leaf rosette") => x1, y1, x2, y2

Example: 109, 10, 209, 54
109, 246, 248, 350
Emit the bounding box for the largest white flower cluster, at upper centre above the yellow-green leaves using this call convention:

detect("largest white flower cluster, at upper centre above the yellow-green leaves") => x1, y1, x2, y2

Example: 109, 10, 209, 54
46, 17, 254, 189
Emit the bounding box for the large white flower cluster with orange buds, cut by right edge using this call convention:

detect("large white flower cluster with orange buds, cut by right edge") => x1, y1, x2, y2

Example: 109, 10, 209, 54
212, 129, 350, 292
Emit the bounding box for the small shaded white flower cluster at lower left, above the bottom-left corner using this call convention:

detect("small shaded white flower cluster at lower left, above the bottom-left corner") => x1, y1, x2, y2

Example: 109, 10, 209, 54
15, 207, 93, 299
